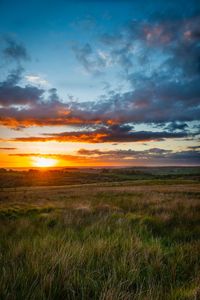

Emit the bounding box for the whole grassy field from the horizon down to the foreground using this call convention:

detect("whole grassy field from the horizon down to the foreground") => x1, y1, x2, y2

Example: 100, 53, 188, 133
0, 168, 200, 300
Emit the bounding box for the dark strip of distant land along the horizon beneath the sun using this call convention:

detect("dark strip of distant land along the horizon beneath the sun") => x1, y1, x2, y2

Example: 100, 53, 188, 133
0, 167, 200, 188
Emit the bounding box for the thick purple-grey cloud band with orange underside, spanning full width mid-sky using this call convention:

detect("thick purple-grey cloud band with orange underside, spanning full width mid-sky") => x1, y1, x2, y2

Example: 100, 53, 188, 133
0, 62, 200, 135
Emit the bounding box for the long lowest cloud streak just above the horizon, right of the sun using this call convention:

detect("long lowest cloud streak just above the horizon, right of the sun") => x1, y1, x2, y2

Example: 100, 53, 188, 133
10, 148, 200, 166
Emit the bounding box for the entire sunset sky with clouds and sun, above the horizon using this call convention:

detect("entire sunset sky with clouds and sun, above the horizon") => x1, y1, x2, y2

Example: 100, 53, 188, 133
0, 0, 200, 168
